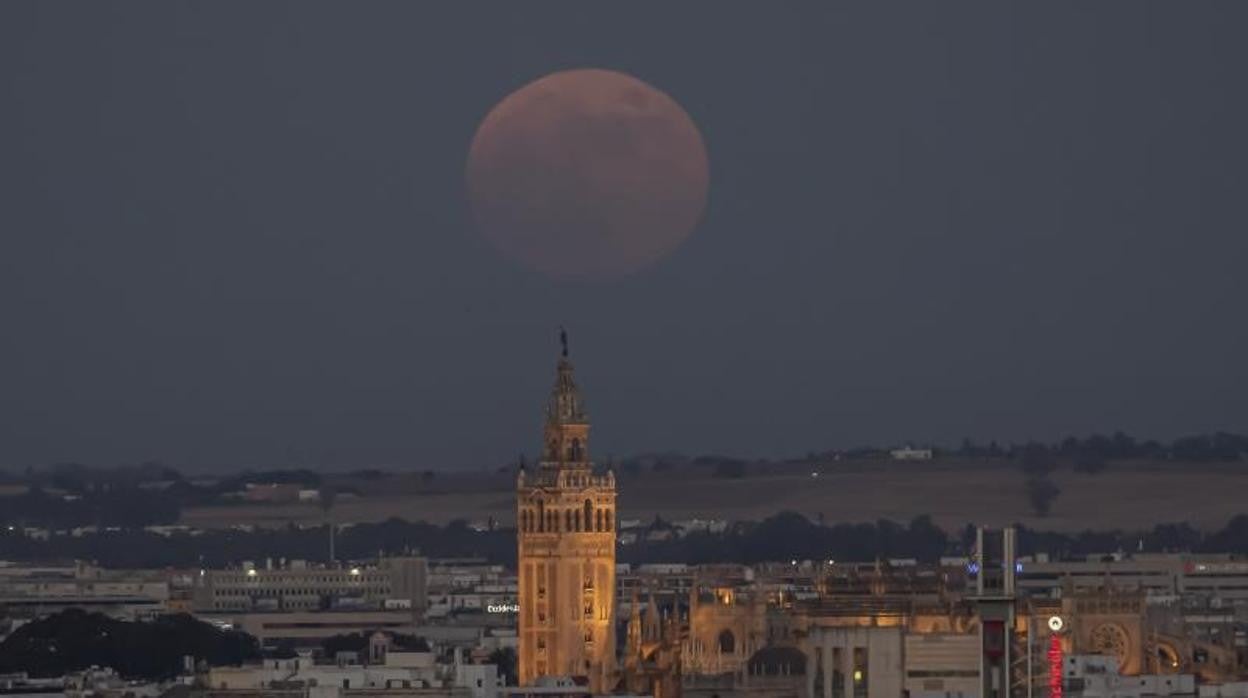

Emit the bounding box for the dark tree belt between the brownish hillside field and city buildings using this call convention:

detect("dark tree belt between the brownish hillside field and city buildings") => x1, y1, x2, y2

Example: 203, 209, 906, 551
7, 512, 1248, 569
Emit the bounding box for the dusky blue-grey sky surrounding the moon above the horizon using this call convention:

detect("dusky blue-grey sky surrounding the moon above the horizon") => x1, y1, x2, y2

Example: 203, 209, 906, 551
0, 0, 1248, 468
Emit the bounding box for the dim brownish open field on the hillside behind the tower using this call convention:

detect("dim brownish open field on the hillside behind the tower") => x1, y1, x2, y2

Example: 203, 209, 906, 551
183, 461, 1248, 531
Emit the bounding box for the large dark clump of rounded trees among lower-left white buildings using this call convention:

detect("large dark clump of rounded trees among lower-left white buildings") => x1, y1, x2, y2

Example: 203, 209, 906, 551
0, 609, 260, 679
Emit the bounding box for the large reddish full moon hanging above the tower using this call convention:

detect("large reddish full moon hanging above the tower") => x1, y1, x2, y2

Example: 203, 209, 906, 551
467, 70, 708, 280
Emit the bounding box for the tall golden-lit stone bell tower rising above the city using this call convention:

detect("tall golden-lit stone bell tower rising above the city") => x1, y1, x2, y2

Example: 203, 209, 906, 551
515, 335, 615, 693
